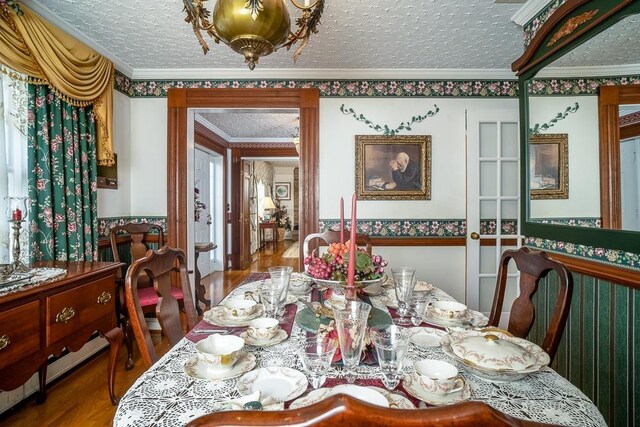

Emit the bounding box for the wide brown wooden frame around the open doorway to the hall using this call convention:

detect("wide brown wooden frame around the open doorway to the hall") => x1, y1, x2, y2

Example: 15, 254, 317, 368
167, 88, 320, 272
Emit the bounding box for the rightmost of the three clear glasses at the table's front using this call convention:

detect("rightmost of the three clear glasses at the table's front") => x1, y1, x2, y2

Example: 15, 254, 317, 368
371, 325, 409, 390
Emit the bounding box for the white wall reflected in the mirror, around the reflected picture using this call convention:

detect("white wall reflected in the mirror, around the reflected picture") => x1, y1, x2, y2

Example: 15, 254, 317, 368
529, 96, 600, 218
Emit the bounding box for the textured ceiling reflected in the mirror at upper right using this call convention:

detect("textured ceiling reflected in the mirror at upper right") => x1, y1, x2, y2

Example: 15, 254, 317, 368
550, 15, 640, 68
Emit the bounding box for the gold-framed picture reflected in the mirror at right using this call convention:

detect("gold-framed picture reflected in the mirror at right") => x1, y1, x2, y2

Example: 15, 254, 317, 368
529, 133, 569, 200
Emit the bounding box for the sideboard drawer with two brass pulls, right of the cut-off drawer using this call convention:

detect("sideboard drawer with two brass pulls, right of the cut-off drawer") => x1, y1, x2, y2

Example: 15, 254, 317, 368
47, 277, 116, 345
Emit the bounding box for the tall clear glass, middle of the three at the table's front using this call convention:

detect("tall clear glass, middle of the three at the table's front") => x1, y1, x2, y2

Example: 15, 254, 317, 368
333, 300, 371, 383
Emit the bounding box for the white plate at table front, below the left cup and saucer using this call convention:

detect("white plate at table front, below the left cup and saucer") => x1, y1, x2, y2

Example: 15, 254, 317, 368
237, 366, 309, 402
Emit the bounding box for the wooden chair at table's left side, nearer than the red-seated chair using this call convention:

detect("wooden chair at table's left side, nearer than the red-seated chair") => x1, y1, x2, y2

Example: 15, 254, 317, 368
124, 246, 197, 369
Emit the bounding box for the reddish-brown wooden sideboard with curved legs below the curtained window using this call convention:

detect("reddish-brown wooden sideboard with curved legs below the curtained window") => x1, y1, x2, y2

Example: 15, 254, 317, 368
0, 262, 122, 405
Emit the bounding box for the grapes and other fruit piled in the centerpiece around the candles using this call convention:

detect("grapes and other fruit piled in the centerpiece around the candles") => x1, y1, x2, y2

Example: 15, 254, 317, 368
304, 242, 387, 281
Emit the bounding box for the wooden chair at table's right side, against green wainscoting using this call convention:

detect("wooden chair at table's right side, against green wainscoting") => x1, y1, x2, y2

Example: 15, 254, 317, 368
489, 247, 573, 362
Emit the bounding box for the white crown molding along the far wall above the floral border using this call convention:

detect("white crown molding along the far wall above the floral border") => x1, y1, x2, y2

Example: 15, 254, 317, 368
131, 68, 516, 80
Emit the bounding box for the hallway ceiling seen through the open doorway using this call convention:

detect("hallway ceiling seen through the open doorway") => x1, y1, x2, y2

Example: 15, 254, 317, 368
198, 110, 299, 142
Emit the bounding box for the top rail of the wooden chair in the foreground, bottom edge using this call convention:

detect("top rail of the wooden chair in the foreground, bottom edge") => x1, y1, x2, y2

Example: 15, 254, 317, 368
187, 394, 550, 427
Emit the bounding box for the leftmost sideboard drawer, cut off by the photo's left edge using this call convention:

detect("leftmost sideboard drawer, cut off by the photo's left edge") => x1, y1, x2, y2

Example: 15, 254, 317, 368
0, 301, 40, 369
